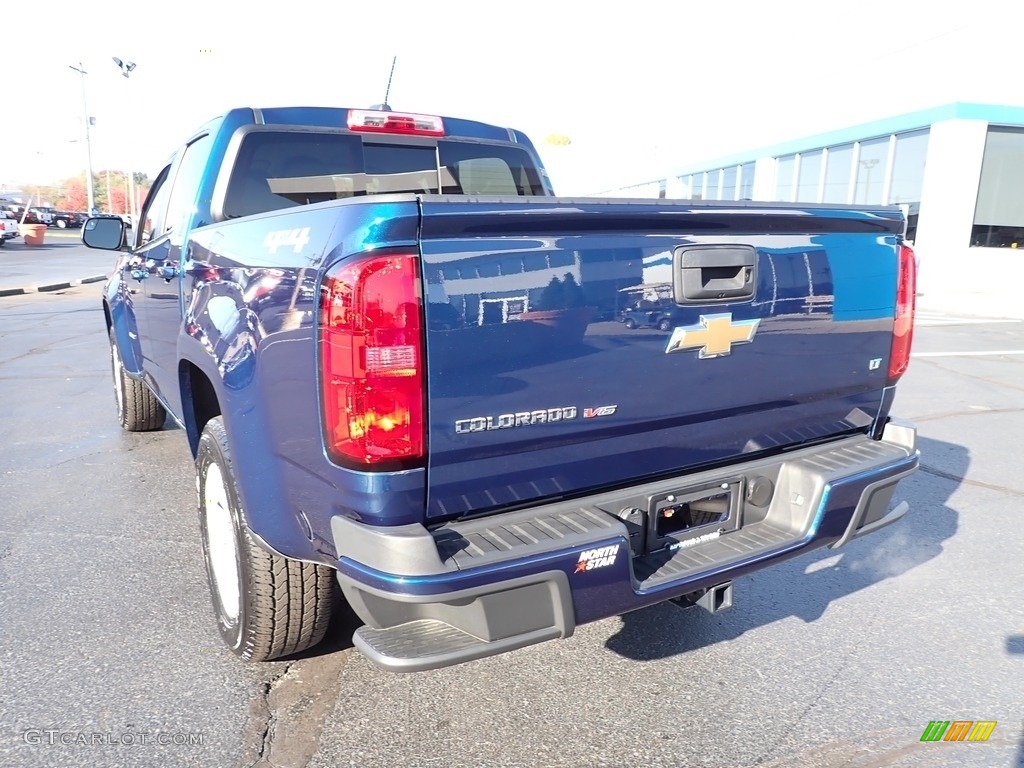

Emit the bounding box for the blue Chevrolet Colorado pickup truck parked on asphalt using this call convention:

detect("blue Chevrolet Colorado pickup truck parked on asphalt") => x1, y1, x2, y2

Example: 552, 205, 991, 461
83, 108, 919, 672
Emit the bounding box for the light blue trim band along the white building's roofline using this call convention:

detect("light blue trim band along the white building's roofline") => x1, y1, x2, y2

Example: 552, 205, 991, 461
608, 101, 1024, 191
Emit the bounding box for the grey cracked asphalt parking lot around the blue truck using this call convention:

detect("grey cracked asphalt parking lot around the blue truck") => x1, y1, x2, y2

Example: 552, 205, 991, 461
0, 284, 1024, 768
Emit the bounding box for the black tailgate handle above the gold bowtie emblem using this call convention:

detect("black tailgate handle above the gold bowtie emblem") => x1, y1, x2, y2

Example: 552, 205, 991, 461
673, 246, 757, 304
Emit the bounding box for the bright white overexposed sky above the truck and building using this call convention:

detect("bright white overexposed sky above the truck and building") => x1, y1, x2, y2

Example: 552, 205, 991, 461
0, 0, 1024, 195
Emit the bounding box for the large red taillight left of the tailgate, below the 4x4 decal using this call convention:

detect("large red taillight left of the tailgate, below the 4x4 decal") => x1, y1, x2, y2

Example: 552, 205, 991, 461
319, 254, 425, 469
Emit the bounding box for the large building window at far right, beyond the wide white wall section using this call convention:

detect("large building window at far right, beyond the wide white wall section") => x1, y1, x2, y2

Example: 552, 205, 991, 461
971, 127, 1024, 248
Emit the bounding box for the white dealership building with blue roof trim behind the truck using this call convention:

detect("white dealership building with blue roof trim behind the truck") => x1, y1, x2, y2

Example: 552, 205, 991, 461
599, 102, 1024, 317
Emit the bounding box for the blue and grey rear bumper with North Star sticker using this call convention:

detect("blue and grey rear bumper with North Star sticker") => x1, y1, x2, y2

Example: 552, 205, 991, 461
332, 421, 919, 672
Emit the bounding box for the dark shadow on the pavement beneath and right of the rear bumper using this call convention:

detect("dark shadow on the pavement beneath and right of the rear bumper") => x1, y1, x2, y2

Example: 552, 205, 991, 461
605, 436, 970, 660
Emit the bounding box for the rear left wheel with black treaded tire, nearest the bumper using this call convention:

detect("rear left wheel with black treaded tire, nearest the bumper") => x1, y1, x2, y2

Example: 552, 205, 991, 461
196, 416, 339, 662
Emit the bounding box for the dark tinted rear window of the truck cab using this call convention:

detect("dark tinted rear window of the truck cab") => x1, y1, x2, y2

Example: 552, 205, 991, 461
222, 129, 546, 218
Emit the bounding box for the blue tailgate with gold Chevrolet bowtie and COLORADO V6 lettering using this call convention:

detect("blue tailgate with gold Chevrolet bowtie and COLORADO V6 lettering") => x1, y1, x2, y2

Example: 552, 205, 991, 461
421, 196, 903, 519
